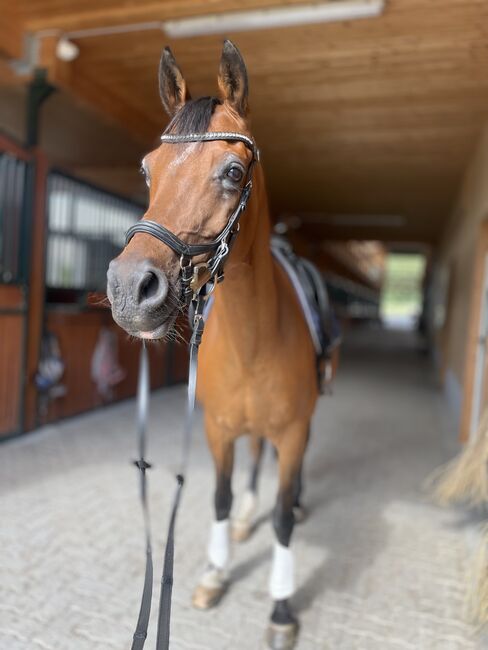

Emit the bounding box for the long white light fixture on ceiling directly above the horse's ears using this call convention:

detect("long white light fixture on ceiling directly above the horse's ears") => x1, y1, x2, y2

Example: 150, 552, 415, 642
163, 0, 385, 38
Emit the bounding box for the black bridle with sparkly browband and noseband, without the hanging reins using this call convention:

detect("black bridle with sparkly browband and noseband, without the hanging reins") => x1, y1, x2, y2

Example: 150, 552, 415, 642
125, 131, 259, 304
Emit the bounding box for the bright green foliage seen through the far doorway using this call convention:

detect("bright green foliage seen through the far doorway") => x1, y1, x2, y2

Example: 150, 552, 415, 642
381, 253, 425, 316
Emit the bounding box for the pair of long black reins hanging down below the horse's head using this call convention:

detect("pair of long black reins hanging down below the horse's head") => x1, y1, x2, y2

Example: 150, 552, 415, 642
131, 295, 205, 650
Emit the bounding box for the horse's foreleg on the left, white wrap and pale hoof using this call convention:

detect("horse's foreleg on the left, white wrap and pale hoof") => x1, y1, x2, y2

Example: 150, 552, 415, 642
192, 421, 234, 609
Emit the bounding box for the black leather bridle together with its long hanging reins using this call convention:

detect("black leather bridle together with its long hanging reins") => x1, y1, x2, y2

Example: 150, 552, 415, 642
126, 131, 259, 650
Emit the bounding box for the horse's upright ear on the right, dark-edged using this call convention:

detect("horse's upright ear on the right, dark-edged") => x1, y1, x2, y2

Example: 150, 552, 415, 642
219, 40, 248, 117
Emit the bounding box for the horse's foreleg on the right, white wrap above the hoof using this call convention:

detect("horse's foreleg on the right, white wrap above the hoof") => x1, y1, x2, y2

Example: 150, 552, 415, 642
267, 423, 308, 650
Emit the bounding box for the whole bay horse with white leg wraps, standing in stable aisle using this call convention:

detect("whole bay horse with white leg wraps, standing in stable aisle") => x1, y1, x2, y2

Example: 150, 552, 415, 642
107, 40, 318, 649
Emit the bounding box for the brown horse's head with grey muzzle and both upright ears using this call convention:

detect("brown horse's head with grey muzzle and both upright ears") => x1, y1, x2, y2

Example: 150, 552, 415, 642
107, 41, 255, 339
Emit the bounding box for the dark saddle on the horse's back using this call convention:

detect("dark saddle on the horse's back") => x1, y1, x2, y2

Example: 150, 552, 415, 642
271, 235, 341, 393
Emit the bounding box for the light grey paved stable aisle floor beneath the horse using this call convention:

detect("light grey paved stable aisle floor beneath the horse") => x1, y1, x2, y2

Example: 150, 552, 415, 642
0, 331, 486, 650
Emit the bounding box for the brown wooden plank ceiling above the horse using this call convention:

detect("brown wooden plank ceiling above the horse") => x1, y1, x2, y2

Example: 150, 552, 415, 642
0, 0, 488, 242
